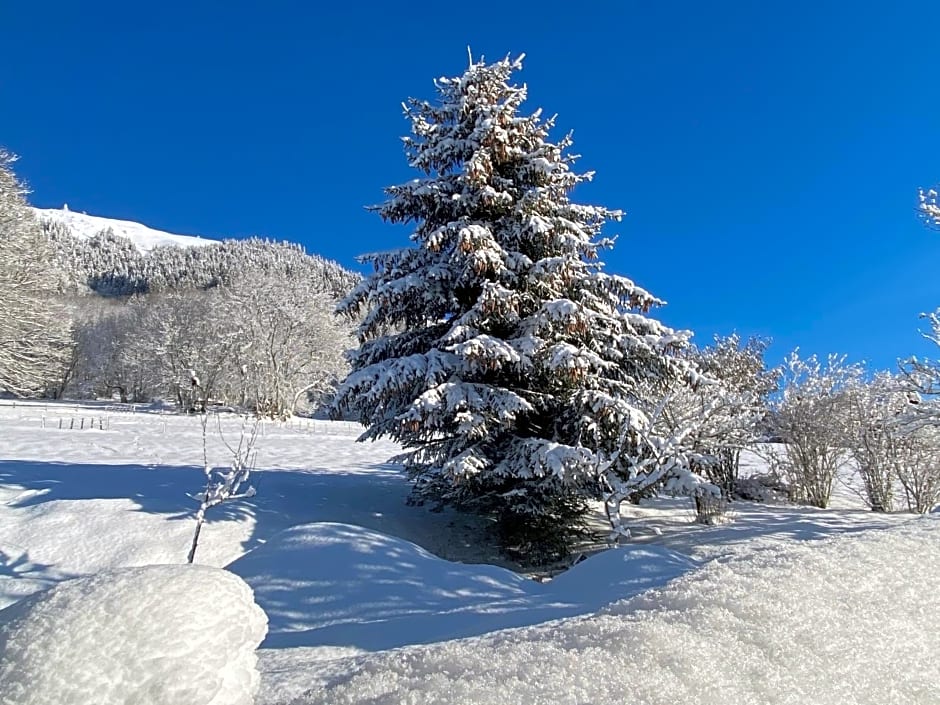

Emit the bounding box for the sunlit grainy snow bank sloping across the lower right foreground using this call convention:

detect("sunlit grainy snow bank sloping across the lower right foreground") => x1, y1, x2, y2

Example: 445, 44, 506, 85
295, 518, 940, 705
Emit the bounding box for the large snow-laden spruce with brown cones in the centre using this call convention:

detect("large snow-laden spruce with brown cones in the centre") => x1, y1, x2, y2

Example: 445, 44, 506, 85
334, 57, 691, 562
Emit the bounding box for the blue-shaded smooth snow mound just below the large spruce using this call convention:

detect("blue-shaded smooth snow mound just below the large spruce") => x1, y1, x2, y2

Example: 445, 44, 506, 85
228, 522, 696, 651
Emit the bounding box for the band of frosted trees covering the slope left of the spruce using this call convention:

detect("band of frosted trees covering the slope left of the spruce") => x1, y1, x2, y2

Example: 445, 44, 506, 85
0, 152, 359, 416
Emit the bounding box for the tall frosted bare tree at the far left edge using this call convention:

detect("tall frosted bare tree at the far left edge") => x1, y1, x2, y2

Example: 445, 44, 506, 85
0, 149, 71, 396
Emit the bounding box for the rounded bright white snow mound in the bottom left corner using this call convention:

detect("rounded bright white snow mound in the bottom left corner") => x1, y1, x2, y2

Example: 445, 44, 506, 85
0, 565, 266, 705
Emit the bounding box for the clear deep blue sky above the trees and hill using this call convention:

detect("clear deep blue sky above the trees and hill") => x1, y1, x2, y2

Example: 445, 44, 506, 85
0, 0, 940, 368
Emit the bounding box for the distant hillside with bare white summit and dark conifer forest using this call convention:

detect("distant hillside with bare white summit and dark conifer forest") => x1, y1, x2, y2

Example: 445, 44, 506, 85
34, 208, 360, 298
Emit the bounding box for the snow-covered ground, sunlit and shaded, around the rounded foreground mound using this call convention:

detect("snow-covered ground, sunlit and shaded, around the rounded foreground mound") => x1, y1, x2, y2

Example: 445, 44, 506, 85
0, 401, 940, 704
